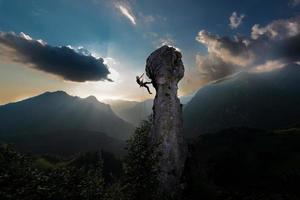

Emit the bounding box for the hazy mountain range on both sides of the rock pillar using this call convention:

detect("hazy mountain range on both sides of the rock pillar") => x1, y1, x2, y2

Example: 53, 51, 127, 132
0, 64, 300, 154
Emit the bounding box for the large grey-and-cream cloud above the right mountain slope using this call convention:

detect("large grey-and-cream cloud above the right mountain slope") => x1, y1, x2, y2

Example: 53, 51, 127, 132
196, 16, 300, 81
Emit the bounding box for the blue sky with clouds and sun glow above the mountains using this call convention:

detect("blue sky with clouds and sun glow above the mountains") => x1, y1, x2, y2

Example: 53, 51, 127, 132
0, 0, 300, 104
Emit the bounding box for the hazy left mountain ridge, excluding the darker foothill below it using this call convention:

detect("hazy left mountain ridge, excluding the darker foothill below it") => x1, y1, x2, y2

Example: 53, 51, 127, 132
0, 91, 134, 140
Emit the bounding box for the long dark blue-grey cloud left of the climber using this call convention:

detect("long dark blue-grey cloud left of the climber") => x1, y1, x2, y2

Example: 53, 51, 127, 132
0, 32, 111, 82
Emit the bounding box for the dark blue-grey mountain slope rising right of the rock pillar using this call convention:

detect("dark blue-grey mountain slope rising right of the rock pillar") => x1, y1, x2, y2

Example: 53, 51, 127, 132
183, 64, 300, 137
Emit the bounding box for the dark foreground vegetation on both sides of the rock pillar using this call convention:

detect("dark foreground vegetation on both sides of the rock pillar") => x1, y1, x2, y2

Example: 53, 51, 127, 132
0, 124, 300, 200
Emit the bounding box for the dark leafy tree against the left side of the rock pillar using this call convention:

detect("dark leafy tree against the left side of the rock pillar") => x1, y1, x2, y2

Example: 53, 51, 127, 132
124, 121, 160, 200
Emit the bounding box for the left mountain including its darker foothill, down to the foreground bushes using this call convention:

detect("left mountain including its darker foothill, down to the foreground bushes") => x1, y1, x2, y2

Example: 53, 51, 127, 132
0, 91, 134, 154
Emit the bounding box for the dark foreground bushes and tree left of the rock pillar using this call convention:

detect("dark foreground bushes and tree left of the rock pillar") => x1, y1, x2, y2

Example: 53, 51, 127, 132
0, 121, 159, 200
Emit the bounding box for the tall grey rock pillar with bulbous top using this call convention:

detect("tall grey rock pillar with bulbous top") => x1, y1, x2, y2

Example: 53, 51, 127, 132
146, 46, 186, 198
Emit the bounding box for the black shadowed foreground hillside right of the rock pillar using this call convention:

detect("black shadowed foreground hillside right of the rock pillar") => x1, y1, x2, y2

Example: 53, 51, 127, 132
185, 128, 300, 200
